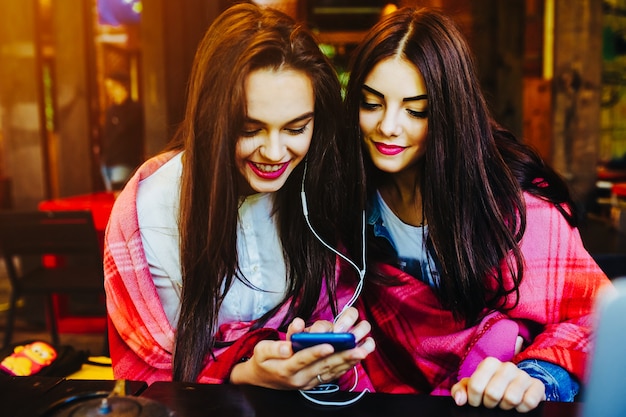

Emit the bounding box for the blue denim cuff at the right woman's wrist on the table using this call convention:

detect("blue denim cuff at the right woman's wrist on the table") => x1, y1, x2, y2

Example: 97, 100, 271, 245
517, 359, 580, 402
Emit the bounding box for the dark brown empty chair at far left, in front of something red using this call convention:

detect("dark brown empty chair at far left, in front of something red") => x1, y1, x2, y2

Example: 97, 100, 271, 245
0, 210, 106, 347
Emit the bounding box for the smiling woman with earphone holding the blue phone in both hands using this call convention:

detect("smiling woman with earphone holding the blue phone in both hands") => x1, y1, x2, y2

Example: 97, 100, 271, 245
105, 4, 374, 389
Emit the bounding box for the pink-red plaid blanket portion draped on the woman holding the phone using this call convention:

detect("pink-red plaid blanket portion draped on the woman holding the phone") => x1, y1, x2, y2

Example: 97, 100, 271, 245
104, 153, 344, 383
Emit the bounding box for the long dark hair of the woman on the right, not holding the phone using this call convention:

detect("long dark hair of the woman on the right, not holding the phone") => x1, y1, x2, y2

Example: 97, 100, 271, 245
346, 7, 576, 322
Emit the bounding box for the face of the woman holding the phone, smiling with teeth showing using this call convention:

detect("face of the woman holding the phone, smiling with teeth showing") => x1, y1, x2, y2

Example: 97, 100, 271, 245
235, 69, 315, 193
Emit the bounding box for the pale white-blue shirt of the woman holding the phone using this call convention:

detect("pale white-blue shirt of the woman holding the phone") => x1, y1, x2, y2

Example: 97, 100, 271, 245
137, 153, 286, 328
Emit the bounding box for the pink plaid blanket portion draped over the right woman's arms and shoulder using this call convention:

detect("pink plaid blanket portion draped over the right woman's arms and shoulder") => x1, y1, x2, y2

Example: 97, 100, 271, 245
348, 195, 612, 394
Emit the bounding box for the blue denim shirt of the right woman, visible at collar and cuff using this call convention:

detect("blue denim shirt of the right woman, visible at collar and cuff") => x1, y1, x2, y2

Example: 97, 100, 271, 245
367, 198, 580, 402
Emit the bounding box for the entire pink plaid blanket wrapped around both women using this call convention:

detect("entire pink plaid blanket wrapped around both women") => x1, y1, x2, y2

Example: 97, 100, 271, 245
104, 154, 610, 394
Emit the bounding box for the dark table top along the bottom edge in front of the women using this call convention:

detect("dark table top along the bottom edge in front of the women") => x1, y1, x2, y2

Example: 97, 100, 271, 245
0, 377, 580, 417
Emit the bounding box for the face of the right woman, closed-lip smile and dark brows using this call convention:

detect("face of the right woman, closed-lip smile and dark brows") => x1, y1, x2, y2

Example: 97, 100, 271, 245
359, 58, 428, 173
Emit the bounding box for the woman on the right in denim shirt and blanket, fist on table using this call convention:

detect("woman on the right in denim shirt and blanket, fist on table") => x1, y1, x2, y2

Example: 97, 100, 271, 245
346, 8, 609, 412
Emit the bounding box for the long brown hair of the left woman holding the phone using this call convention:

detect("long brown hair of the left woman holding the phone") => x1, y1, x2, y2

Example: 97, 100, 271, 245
165, 4, 355, 381
